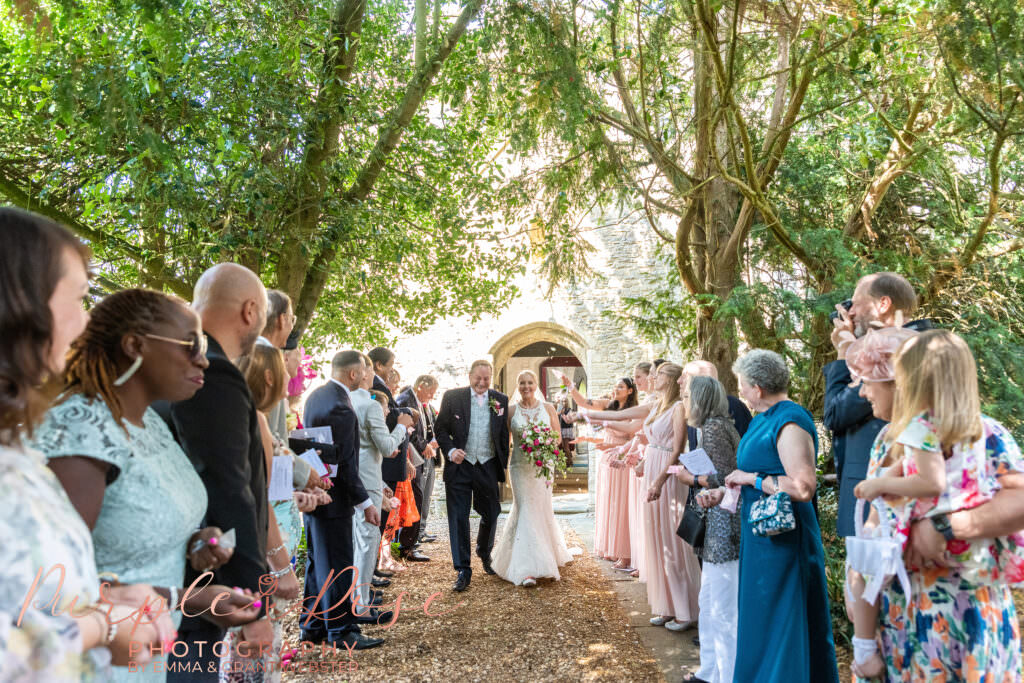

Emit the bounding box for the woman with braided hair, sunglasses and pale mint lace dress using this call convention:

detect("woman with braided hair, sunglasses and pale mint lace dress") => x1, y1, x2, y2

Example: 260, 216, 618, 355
34, 289, 258, 683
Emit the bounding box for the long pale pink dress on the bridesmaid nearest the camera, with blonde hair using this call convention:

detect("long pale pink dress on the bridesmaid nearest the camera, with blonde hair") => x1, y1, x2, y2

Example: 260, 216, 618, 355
643, 409, 700, 622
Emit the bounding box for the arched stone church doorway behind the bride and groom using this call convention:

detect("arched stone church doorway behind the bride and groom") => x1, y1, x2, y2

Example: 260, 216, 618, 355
490, 323, 592, 499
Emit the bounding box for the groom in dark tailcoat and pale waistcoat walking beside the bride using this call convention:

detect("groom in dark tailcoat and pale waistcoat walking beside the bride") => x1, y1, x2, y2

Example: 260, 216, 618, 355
434, 360, 509, 591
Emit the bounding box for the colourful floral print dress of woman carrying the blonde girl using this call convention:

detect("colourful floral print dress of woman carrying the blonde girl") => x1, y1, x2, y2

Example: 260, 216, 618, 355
855, 417, 1024, 683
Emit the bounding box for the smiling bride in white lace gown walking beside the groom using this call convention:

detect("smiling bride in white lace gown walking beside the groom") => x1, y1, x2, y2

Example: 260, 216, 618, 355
492, 370, 572, 587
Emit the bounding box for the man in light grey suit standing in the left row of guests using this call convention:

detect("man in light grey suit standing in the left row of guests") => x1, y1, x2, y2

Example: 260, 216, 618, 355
349, 356, 413, 623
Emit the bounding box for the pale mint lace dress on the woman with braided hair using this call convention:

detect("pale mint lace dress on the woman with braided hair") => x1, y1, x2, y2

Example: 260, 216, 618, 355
34, 394, 207, 683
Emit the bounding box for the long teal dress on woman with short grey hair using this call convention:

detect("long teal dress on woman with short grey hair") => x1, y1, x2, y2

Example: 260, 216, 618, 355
734, 400, 839, 683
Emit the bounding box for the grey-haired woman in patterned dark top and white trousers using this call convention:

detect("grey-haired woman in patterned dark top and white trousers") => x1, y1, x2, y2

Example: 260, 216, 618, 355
676, 377, 739, 683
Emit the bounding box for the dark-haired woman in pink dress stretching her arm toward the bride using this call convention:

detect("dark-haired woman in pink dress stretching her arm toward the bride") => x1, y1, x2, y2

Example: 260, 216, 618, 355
561, 375, 637, 571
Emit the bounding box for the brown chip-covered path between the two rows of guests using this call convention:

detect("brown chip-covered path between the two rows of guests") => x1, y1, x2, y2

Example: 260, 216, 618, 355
284, 514, 665, 683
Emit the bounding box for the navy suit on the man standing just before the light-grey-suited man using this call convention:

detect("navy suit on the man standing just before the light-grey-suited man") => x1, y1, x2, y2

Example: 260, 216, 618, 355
299, 380, 370, 642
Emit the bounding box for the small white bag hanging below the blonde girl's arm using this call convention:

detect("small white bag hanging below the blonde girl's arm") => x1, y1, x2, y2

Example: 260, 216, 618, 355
846, 499, 910, 604
